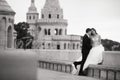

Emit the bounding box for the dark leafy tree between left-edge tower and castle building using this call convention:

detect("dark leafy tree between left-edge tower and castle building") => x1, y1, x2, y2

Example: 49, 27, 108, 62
14, 22, 33, 49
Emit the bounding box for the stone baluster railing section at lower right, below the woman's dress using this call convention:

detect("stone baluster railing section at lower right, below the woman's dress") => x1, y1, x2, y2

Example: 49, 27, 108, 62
87, 65, 120, 80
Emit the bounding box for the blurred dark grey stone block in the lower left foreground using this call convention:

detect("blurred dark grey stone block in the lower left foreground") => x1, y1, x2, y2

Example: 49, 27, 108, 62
0, 49, 38, 80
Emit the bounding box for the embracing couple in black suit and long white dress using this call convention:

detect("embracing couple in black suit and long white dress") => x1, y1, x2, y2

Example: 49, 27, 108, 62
73, 28, 104, 75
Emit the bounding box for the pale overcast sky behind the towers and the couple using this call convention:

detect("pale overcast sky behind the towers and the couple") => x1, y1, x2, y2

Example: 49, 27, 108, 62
7, 0, 120, 42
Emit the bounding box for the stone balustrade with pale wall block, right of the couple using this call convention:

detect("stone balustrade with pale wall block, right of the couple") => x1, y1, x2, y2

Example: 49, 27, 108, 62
87, 51, 120, 80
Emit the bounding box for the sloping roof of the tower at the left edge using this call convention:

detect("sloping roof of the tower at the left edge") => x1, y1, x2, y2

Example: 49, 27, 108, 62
0, 0, 15, 14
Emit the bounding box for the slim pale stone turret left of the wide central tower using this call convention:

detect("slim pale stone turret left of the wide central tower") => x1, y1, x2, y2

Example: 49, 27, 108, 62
26, 0, 39, 36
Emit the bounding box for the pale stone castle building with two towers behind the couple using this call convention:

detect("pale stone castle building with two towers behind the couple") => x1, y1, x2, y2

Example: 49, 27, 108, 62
26, 0, 81, 50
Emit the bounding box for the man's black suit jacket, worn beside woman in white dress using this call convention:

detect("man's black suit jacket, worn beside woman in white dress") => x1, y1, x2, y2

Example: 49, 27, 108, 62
82, 34, 92, 55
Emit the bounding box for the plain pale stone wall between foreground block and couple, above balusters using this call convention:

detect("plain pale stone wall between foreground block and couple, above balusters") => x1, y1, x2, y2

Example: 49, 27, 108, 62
34, 49, 81, 61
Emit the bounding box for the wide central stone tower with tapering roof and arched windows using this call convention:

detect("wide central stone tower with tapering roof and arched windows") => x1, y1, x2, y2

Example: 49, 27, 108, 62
38, 0, 67, 38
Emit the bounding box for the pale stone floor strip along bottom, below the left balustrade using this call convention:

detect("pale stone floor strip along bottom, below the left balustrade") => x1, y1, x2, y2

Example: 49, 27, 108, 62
37, 68, 99, 80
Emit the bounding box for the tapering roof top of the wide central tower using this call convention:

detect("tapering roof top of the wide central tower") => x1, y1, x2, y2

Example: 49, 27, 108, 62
44, 0, 60, 9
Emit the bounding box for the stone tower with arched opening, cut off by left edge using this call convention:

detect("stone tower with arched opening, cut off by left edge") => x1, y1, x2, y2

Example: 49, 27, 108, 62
0, 0, 15, 49
